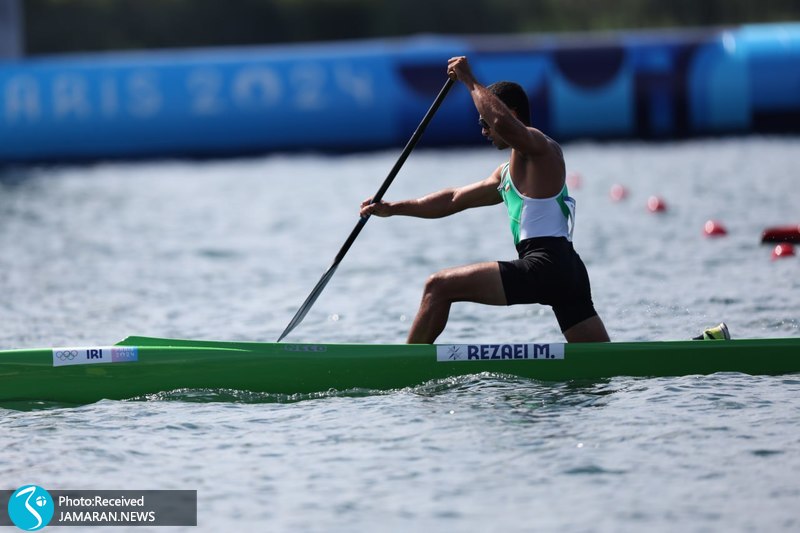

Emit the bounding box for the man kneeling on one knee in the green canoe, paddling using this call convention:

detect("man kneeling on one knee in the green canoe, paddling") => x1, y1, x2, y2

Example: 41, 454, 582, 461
361, 57, 609, 344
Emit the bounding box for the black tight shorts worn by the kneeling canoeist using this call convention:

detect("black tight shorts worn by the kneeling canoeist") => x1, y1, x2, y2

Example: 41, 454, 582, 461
498, 237, 597, 332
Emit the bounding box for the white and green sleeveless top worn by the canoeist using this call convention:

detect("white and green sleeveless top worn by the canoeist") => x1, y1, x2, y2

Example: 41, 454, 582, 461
497, 163, 575, 244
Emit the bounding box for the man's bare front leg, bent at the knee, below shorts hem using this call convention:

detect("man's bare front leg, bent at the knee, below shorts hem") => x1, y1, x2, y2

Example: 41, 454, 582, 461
406, 262, 506, 344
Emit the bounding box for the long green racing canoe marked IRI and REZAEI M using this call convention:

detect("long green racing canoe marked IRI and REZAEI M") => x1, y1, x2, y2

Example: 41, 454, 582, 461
0, 337, 800, 404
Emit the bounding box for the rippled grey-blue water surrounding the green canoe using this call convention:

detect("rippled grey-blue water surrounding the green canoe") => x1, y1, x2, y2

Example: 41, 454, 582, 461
0, 137, 800, 532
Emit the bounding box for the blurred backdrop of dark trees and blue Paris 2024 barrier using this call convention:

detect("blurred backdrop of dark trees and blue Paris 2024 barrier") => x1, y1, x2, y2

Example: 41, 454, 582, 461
0, 0, 800, 165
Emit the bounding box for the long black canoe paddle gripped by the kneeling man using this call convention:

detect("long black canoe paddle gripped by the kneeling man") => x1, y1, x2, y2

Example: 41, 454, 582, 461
278, 78, 453, 342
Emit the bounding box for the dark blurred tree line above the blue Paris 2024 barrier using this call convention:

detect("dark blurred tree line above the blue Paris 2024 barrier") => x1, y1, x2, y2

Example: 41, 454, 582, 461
21, 0, 800, 55
